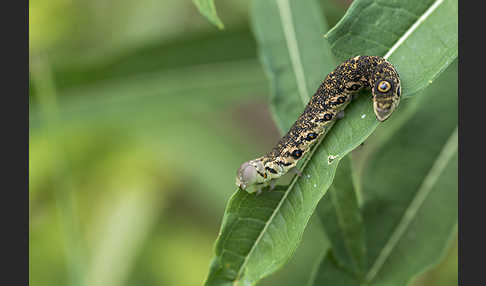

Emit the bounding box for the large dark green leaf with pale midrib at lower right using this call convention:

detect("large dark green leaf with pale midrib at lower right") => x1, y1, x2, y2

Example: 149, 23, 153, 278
314, 61, 458, 285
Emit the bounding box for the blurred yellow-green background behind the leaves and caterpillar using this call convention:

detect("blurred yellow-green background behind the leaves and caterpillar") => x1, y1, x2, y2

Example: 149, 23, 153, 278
29, 0, 457, 286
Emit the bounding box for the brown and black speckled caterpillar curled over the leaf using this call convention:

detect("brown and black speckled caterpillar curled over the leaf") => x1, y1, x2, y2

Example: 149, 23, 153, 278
236, 56, 400, 192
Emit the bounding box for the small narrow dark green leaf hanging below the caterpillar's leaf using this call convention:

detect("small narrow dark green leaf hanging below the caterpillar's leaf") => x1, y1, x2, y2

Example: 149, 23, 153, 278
317, 156, 366, 274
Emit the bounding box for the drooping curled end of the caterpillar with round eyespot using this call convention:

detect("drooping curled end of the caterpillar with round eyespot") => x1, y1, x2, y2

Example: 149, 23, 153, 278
371, 61, 400, 122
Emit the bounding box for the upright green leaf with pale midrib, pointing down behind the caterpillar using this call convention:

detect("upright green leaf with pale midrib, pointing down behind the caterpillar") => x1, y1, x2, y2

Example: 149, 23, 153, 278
253, 0, 337, 133
